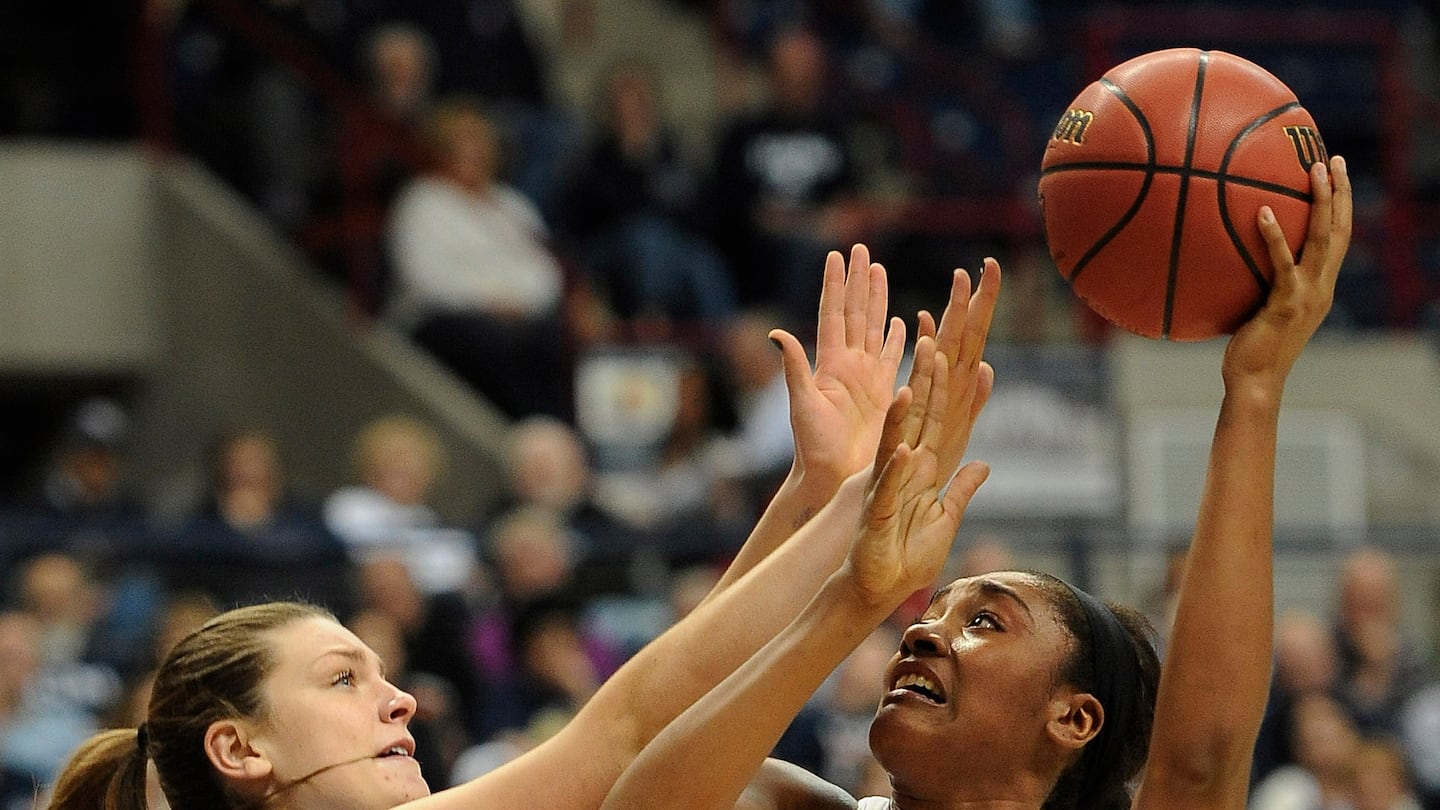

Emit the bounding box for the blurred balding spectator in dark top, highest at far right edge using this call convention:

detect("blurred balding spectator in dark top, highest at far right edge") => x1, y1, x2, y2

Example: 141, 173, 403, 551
1335, 548, 1427, 735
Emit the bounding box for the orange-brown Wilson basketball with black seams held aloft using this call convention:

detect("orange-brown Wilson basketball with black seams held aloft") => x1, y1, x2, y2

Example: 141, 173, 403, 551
1040, 48, 1326, 340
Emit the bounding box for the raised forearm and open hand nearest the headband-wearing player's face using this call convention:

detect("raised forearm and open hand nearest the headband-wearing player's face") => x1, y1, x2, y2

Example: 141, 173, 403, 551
603, 337, 988, 810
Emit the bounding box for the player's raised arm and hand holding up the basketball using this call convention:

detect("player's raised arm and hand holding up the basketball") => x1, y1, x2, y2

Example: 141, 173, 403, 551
1136, 157, 1351, 810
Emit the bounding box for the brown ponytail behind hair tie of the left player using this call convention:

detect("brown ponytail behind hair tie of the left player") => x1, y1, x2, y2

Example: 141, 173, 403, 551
49, 728, 148, 810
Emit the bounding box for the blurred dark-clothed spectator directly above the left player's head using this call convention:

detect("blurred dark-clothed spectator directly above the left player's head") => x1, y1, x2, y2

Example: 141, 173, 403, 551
164, 430, 348, 610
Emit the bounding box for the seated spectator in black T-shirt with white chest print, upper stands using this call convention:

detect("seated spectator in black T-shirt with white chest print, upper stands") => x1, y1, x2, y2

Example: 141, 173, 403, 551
708, 29, 858, 321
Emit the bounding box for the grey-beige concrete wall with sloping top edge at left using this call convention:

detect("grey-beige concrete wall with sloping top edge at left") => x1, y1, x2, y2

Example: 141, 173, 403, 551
0, 146, 504, 520
